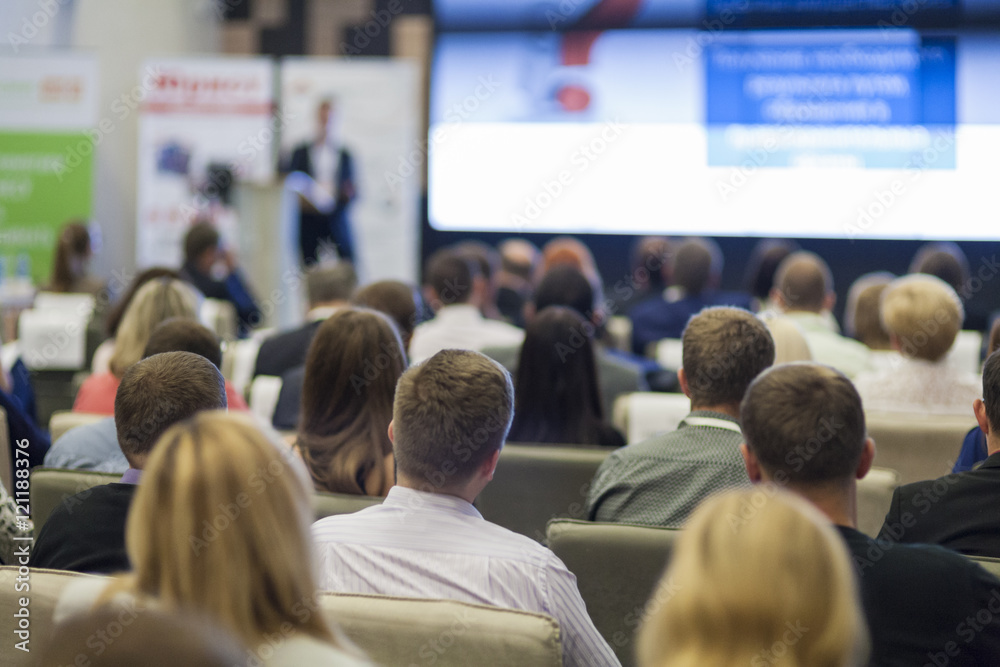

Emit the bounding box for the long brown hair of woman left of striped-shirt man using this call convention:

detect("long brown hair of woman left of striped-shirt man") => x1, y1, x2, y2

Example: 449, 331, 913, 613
296, 308, 406, 495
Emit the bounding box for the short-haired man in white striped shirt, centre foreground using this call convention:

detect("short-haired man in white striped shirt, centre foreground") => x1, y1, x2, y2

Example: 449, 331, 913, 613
313, 350, 619, 667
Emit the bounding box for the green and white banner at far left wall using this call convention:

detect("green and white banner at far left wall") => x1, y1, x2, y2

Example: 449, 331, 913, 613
0, 51, 101, 285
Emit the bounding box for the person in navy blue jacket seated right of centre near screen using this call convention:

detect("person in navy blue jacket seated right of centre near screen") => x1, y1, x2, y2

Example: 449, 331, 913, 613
630, 239, 752, 355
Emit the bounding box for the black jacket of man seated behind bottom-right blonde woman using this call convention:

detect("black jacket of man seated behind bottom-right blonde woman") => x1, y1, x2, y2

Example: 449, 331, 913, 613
837, 526, 1000, 667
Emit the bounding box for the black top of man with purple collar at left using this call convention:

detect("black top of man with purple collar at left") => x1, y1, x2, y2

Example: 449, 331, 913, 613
28, 483, 138, 574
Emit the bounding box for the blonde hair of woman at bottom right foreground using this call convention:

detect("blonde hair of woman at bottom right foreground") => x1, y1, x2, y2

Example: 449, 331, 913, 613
638, 487, 868, 667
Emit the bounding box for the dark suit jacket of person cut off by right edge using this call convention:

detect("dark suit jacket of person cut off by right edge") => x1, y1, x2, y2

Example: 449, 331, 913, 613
879, 452, 1000, 556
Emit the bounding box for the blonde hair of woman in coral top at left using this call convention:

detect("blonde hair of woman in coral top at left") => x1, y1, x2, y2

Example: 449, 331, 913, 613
109, 278, 198, 377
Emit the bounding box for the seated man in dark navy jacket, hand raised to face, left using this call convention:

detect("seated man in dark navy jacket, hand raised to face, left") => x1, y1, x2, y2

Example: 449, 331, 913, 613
181, 221, 261, 337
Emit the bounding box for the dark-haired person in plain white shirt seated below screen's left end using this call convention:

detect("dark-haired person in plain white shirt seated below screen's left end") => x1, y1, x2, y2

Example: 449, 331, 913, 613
410, 248, 524, 363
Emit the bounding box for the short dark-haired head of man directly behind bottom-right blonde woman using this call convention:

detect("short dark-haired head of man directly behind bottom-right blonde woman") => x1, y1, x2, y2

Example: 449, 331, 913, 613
740, 363, 875, 500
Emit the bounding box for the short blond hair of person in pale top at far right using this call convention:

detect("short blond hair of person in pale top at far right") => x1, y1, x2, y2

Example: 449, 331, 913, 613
880, 274, 965, 361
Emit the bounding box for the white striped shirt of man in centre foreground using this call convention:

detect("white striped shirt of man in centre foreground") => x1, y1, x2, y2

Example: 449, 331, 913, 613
312, 486, 619, 667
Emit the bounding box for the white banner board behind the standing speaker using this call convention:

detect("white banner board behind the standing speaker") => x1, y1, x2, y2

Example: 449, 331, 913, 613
281, 58, 421, 282
